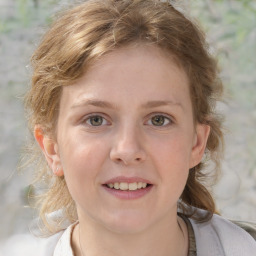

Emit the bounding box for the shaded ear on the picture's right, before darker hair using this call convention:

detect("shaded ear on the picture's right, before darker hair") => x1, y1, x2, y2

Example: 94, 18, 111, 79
190, 124, 210, 168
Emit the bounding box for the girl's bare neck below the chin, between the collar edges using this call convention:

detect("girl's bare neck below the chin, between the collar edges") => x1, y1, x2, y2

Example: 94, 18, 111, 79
72, 212, 188, 256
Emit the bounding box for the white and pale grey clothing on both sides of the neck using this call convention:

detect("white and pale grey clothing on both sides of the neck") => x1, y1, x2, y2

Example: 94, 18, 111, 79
0, 210, 256, 256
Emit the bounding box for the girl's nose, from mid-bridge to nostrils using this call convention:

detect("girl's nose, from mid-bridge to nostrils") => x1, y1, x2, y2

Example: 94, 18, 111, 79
110, 125, 146, 165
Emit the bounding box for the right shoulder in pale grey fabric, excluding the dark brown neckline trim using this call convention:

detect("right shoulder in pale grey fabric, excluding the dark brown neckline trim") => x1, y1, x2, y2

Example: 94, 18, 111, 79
190, 210, 256, 256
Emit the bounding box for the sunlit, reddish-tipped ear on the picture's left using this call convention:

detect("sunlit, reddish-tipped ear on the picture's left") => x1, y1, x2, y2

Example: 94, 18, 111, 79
34, 125, 64, 176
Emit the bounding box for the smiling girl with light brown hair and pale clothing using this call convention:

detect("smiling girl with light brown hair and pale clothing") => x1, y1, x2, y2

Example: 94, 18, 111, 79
26, 0, 256, 256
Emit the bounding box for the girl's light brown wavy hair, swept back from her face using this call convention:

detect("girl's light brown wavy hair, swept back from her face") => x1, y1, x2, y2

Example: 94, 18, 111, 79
25, 0, 223, 235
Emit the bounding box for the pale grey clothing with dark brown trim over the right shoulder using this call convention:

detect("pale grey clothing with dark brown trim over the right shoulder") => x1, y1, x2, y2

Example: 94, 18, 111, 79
179, 210, 256, 256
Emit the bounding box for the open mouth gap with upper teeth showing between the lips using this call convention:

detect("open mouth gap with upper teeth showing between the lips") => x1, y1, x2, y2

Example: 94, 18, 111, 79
103, 181, 153, 191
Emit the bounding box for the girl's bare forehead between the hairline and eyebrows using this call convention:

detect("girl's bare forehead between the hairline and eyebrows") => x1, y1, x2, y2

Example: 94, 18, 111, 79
60, 45, 189, 109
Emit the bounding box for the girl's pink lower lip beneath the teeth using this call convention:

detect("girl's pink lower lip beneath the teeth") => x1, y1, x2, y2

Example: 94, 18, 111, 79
103, 185, 153, 200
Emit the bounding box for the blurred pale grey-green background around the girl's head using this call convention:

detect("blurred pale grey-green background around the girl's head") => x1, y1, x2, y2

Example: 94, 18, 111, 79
0, 0, 256, 248
